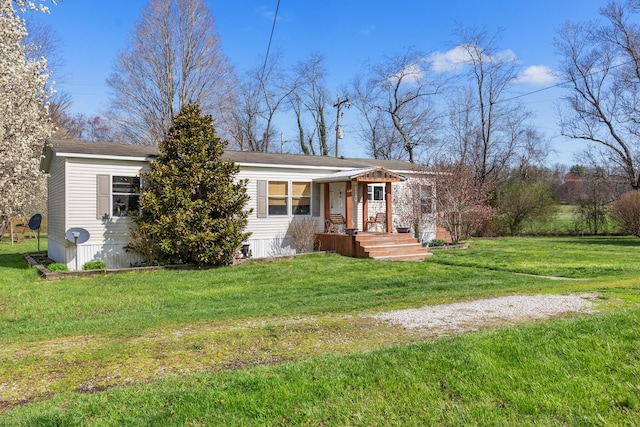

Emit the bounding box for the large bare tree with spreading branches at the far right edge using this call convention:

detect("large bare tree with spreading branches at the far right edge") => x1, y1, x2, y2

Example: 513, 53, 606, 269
556, 0, 640, 189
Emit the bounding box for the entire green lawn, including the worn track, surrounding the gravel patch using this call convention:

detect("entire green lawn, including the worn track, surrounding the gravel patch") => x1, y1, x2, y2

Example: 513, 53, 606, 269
0, 237, 640, 425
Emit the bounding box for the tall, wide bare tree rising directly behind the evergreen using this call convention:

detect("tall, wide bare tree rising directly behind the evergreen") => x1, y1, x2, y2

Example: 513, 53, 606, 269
107, 0, 235, 144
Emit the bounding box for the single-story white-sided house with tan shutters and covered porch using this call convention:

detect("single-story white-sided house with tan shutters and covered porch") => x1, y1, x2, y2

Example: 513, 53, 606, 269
41, 139, 436, 269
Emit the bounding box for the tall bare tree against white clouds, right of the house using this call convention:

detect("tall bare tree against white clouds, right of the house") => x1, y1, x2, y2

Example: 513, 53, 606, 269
449, 29, 531, 182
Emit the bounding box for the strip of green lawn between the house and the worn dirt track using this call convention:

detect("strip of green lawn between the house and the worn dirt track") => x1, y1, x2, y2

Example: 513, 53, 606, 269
0, 244, 568, 342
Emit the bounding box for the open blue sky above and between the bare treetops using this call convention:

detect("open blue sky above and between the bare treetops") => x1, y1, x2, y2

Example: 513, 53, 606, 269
33, 0, 605, 164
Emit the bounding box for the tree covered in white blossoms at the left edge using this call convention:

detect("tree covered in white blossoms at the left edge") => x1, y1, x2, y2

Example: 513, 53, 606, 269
0, 0, 55, 216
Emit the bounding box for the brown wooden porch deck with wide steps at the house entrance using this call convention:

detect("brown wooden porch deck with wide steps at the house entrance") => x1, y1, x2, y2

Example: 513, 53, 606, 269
317, 232, 432, 261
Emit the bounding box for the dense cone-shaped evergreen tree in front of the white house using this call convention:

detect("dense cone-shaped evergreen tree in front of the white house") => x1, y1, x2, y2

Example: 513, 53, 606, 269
137, 104, 250, 265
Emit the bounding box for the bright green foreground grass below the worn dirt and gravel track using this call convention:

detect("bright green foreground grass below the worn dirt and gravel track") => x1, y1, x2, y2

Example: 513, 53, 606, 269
4, 309, 640, 426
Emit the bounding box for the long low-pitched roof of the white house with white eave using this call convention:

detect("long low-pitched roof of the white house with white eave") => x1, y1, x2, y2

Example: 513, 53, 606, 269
40, 139, 415, 172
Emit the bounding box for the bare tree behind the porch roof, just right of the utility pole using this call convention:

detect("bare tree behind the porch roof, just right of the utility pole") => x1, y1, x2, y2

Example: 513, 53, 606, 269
351, 48, 440, 163
